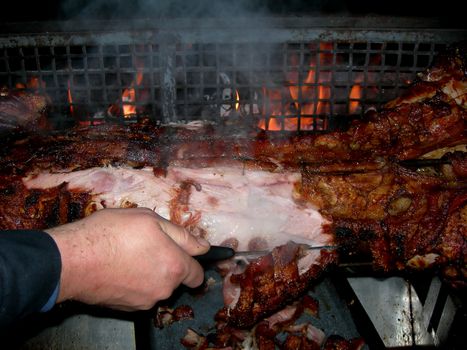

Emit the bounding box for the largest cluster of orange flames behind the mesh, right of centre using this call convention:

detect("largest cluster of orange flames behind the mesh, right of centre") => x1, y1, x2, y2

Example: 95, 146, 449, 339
258, 43, 362, 131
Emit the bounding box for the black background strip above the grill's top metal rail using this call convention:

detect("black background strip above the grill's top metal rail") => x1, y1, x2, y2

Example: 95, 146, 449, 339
0, 0, 467, 26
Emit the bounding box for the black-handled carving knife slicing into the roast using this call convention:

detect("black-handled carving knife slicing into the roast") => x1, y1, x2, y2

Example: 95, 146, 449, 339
193, 244, 337, 264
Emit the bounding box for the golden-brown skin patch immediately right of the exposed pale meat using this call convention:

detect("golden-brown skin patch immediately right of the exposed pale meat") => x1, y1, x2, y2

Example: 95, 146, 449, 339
298, 164, 456, 220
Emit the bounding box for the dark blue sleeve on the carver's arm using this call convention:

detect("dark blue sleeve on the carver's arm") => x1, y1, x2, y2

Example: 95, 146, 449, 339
0, 230, 62, 329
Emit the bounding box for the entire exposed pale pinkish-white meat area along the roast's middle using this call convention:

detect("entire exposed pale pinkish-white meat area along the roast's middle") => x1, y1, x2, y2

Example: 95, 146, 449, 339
24, 167, 332, 250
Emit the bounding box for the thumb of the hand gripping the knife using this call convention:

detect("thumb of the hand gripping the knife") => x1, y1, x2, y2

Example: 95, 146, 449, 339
160, 220, 210, 256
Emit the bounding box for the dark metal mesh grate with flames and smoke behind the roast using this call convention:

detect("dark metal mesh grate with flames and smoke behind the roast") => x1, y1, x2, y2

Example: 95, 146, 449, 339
0, 17, 465, 131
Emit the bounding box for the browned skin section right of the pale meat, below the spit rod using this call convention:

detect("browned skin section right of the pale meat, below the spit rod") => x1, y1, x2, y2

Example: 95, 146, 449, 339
298, 152, 467, 285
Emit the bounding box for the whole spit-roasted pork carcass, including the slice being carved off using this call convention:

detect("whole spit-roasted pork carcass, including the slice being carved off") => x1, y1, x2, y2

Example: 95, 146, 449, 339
0, 43, 467, 325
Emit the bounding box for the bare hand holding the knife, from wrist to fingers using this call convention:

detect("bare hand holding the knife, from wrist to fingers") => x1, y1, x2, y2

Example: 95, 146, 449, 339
46, 208, 209, 311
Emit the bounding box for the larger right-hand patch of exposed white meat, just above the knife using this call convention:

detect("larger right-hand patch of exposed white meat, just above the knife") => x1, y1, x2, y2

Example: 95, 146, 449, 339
169, 167, 331, 250
